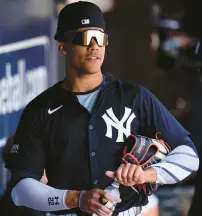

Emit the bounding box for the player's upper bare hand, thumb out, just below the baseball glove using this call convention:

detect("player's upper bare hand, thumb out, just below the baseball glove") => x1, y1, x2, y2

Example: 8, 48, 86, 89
106, 163, 146, 186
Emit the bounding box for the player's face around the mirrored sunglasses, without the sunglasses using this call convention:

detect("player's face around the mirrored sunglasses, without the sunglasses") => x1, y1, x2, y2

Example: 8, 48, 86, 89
58, 27, 105, 74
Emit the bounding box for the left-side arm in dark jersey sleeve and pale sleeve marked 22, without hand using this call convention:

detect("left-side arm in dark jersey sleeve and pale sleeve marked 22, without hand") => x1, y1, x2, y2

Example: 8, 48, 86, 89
7, 102, 74, 211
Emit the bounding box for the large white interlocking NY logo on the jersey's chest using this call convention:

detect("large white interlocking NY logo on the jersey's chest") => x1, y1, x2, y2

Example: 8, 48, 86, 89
102, 107, 136, 142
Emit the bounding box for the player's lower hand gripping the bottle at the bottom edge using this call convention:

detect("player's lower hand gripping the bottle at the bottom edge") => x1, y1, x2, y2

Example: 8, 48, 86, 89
81, 189, 114, 216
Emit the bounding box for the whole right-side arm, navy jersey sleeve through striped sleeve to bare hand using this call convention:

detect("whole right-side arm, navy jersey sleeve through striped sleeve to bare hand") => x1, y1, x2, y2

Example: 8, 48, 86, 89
108, 87, 199, 185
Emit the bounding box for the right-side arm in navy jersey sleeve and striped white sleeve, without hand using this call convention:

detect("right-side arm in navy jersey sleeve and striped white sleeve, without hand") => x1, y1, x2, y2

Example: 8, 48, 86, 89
139, 88, 199, 184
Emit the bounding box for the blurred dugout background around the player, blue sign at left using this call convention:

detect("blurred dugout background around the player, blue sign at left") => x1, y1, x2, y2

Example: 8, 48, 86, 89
0, 0, 202, 216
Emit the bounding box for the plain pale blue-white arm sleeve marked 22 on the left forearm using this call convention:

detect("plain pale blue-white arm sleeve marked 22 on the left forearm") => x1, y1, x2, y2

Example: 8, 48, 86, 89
11, 178, 68, 212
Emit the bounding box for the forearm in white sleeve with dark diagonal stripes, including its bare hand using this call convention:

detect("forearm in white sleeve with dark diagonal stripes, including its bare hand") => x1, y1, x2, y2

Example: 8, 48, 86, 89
106, 137, 199, 186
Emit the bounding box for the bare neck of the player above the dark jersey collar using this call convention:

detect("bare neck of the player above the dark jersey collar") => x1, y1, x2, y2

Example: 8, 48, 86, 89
62, 71, 103, 92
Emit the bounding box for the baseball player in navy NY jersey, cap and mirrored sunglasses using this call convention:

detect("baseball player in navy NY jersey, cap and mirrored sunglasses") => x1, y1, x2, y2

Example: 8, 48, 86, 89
8, 1, 198, 216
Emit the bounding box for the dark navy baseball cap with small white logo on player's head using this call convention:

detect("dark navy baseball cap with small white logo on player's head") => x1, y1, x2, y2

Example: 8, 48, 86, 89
54, 1, 105, 41
